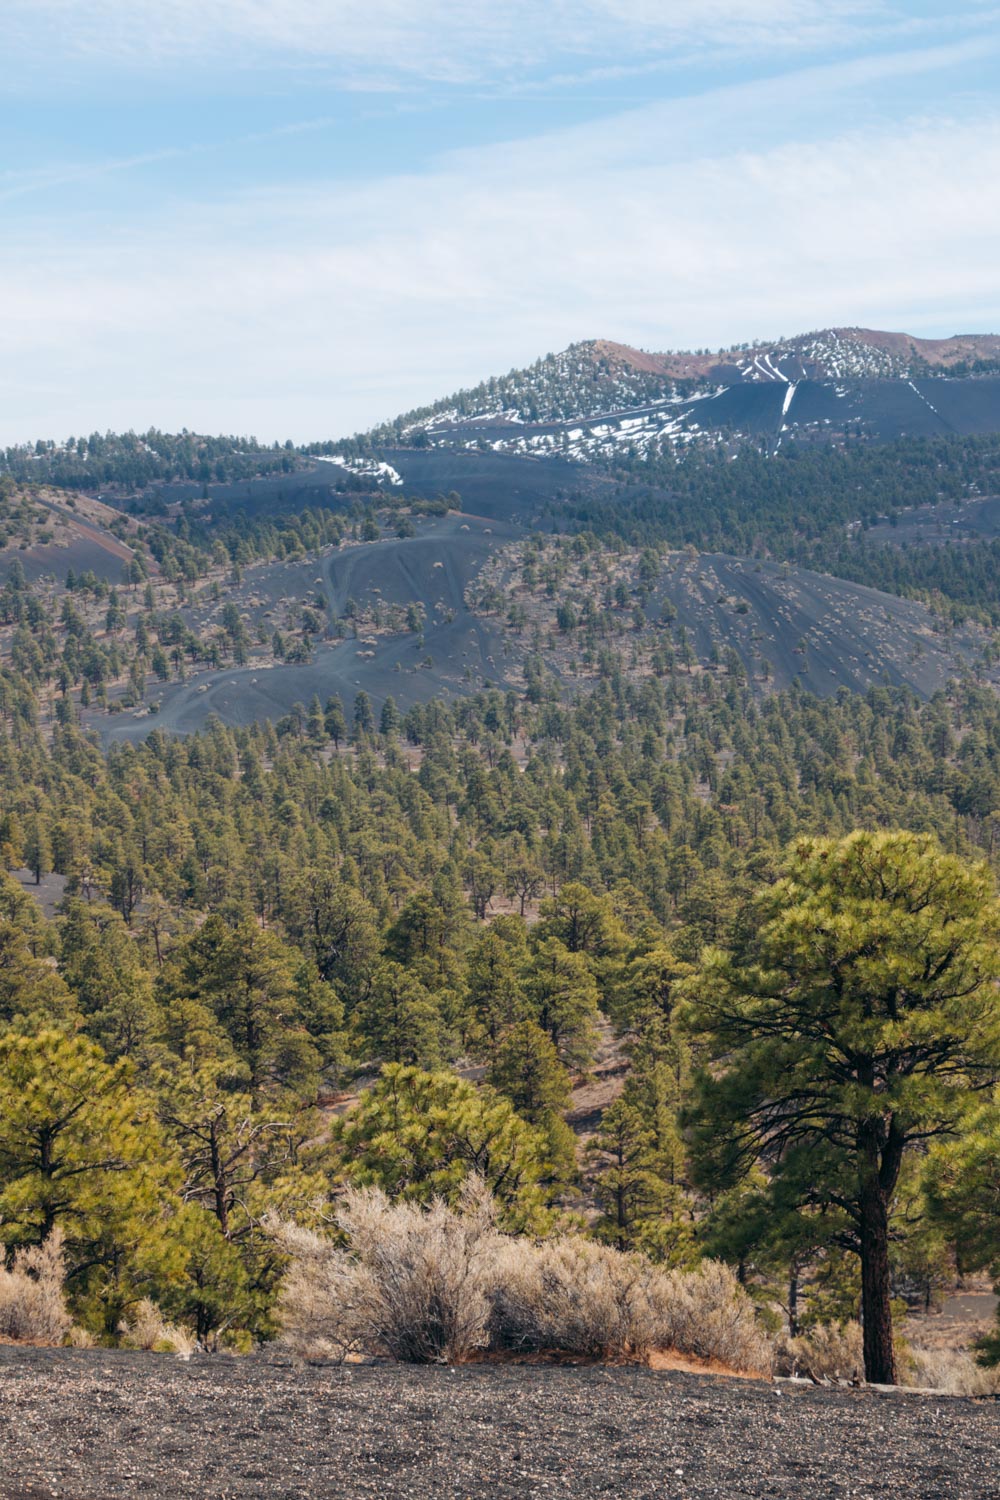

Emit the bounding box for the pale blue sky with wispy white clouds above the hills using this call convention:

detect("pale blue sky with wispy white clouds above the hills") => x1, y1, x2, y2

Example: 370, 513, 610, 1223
0, 0, 1000, 443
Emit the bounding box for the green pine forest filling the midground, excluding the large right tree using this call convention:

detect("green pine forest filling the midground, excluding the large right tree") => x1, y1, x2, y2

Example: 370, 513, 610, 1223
0, 675, 1000, 1380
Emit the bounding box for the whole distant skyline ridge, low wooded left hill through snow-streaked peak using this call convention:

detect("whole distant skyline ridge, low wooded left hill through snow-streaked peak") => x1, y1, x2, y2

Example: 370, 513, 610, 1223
11, 329, 1000, 492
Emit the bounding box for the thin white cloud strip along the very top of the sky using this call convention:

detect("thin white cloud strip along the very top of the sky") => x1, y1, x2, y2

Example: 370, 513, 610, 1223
3, 0, 943, 86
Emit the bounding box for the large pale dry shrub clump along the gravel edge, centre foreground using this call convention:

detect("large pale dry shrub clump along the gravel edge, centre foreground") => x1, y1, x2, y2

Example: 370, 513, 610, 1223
273, 1190, 771, 1371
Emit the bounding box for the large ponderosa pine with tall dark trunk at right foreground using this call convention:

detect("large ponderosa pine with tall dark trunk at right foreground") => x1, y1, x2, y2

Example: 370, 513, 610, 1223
690, 833, 1000, 1385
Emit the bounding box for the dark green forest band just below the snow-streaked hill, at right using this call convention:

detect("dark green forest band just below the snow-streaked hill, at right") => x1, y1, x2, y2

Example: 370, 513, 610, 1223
574, 435, 1000, 624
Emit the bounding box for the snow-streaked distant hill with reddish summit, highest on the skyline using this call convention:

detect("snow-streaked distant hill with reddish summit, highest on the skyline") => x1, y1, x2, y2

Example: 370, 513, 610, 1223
329, 329, 1000, 471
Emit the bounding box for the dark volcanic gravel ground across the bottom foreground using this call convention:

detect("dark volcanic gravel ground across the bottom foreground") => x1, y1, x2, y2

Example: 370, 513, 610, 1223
0, 1349, 1000, 1500
